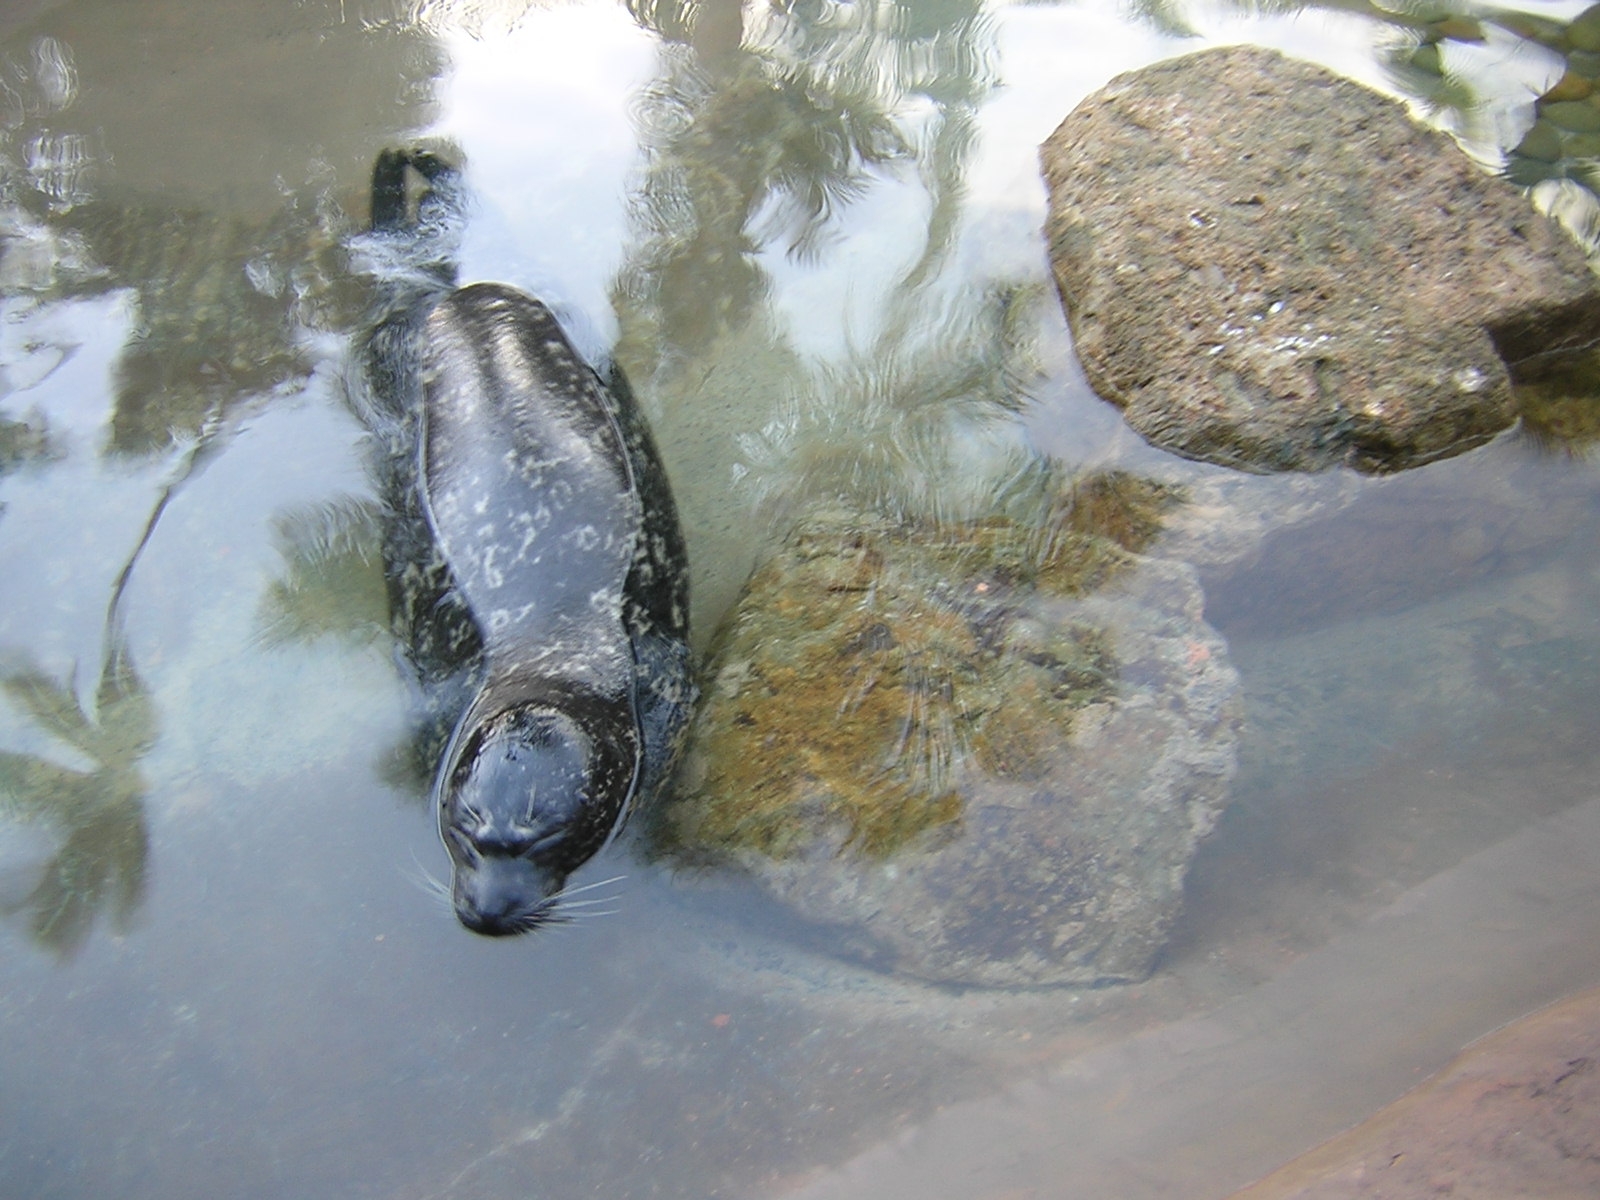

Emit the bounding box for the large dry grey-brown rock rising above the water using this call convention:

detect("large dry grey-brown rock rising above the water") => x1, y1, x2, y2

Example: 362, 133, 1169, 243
1042, 46, 1600, 472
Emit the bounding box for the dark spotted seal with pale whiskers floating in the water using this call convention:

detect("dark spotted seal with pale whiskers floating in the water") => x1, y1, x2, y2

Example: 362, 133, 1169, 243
368, 150, 694, 934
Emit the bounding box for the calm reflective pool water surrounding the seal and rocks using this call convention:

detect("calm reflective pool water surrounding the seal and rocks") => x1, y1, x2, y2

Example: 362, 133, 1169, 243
0, 0, 1600, 1198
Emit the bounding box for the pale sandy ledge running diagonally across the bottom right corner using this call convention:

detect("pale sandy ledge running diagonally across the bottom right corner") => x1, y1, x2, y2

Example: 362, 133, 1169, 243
789, 800, 1600, 1200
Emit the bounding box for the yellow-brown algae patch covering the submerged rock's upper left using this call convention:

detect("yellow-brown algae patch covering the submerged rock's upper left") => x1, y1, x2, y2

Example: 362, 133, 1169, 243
667, 490, 1133, 859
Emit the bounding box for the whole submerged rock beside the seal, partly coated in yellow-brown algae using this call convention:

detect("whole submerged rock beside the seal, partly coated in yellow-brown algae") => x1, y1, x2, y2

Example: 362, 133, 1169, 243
658, 477, 1238, 986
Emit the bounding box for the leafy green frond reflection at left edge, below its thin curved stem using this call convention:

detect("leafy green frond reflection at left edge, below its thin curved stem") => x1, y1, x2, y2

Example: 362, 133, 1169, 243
0, 637, 157, 954
